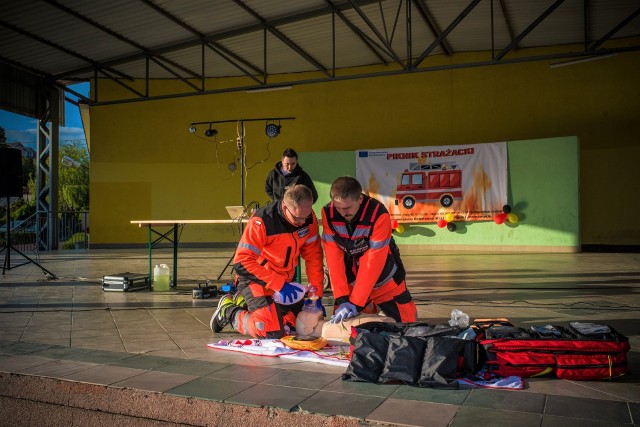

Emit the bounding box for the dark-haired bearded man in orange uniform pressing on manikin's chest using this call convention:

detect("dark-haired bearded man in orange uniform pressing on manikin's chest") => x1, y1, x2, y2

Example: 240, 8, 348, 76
322, 176, 417, 323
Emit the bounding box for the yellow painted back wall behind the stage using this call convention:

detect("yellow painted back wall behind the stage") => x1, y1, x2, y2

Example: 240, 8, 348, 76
90, 44, 640, 245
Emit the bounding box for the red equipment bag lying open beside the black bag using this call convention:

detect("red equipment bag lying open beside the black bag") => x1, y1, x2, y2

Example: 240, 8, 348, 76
478, 322, 630, 380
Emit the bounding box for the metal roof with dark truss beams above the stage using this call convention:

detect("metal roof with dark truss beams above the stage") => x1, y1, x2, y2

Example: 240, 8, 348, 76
0, 0, 640, 104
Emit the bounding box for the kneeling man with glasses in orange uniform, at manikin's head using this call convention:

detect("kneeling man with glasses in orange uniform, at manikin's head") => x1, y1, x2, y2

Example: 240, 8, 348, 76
210, 184, 324, 339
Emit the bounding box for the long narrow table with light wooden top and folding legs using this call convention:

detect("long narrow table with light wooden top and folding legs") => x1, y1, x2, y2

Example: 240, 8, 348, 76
131, 218, 248, 288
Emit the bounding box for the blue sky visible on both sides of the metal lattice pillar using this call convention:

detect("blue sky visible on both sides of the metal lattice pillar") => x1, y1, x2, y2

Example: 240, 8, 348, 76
0, 83, 89, 150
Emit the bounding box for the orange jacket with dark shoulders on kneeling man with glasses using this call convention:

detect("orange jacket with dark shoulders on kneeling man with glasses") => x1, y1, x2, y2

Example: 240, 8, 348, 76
233, 202, 324, 296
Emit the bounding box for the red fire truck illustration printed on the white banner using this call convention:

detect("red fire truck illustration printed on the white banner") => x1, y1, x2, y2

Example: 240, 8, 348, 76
395, 163, 462, 209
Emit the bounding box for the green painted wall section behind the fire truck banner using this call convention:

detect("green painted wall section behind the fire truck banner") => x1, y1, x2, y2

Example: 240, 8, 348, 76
301, 137, 580, 251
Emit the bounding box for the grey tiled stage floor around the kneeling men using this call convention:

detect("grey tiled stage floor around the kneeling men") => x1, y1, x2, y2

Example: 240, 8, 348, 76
0, 249, 640, 427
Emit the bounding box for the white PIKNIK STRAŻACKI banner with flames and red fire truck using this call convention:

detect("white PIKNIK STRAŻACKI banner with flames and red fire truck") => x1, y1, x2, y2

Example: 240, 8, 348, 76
356, 142, 507, 223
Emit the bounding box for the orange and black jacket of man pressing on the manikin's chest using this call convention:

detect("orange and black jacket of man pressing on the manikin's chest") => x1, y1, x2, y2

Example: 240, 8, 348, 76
322, 195, 405, 308
